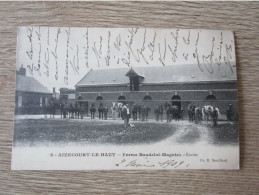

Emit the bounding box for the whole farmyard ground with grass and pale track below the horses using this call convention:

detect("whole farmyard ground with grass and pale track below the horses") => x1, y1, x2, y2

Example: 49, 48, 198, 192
14, 117, 238, 146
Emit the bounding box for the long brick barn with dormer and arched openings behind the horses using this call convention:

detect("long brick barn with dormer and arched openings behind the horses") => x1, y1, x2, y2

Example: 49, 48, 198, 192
75, 65, 237, 117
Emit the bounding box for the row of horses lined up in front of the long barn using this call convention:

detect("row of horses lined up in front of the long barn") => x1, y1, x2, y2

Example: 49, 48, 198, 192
44, 101, 220, 126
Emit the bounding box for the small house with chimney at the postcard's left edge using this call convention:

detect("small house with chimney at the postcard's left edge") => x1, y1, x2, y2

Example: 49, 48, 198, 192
15, 67, 53, 114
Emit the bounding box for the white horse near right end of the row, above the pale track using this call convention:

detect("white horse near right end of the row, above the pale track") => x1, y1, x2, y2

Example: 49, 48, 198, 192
202, 105, 220, 126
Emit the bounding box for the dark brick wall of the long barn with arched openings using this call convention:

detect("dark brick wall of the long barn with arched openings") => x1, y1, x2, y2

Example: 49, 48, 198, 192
76, 82, 238, 119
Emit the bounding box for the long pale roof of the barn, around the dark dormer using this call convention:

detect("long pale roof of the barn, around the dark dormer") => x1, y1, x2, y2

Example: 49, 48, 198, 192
76, 64, 236, 86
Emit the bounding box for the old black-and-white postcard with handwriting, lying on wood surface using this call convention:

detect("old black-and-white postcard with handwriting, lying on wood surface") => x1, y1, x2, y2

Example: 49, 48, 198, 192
12, 26, 239, 170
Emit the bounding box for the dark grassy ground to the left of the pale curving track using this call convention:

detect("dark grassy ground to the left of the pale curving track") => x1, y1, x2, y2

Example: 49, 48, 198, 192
14, 119, 180, 146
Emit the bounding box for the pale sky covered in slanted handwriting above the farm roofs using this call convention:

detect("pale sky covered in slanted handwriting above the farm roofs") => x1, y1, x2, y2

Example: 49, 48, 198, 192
16, 26, 236, 91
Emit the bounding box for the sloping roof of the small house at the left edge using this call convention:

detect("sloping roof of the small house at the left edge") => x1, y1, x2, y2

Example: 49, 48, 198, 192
16, 74, 52, 94
